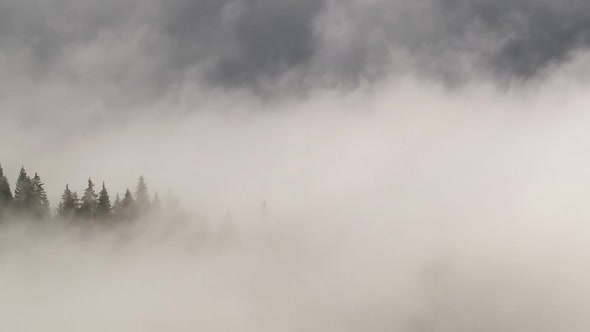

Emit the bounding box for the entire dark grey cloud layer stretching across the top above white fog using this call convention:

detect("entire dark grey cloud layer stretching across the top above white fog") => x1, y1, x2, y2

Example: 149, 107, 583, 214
0, 0, 590, 94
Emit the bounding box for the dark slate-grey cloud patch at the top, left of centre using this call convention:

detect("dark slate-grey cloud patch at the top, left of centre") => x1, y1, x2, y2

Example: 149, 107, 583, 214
164, 0, 323, 85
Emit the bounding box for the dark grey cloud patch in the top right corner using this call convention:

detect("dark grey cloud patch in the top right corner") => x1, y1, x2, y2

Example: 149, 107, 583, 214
442, 0, 590, 76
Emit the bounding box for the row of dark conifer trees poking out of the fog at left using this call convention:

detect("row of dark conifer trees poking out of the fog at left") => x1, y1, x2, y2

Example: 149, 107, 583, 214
0, 165, 168, 222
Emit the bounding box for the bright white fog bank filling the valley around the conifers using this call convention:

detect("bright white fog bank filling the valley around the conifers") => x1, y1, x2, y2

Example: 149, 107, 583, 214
0, 64, 590, 332
